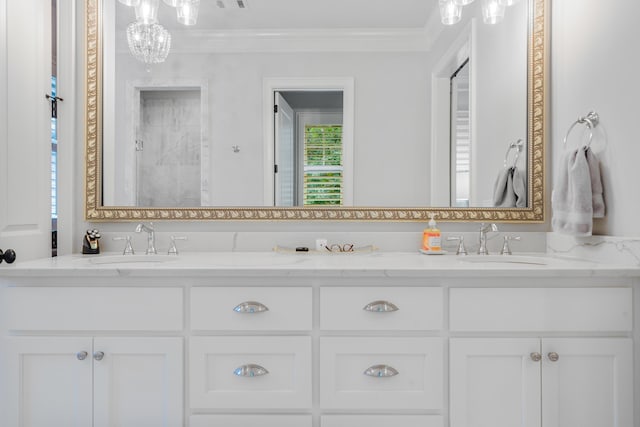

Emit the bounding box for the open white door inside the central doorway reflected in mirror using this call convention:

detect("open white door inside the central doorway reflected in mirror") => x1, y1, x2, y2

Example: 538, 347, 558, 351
274, 92, 296, 206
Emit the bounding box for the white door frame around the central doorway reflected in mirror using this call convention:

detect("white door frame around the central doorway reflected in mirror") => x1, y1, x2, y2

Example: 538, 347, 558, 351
262, 77, 355, 206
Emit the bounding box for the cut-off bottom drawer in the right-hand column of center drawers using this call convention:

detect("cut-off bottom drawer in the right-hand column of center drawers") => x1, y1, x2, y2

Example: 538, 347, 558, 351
320, 415, 444, 427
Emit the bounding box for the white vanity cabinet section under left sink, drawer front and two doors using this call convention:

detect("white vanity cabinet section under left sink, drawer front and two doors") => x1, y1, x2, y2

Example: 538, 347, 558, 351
2, 287, 184, 427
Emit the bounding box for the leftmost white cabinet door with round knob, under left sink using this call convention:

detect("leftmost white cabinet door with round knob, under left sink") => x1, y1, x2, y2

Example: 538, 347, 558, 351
0, 337, 92, 427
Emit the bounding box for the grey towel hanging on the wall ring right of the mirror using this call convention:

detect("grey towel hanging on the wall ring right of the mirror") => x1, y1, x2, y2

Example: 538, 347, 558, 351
551, 147, 604, 236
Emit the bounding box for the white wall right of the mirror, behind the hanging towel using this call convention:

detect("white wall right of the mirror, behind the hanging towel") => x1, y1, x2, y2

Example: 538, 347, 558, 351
549, 0, 640, 236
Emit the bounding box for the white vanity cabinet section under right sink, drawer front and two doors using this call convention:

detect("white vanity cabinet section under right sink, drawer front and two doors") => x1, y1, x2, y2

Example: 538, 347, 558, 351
449, 288, 634, 427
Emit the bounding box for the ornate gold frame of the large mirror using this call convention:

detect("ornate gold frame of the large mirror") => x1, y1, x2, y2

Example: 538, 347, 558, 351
85, 0, 550, 223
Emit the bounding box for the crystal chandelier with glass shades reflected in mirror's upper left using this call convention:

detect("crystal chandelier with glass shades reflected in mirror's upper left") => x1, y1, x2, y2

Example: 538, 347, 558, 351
118, 0, 200, 66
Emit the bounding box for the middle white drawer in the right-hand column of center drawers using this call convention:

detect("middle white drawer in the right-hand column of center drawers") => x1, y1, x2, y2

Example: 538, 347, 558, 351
320, 337, 444, 410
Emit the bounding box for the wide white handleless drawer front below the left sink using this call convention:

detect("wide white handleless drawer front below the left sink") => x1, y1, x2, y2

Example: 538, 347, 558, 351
5, 287, 183, 331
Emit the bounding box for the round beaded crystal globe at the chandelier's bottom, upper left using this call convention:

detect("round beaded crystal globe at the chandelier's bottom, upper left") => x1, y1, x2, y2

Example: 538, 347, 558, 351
127, 22, 171, 65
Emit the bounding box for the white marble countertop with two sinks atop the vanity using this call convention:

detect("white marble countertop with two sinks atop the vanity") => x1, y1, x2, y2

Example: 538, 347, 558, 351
0, 251, 640, 278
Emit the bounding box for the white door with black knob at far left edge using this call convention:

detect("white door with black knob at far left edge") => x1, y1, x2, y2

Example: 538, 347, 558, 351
0, 0, 52, 260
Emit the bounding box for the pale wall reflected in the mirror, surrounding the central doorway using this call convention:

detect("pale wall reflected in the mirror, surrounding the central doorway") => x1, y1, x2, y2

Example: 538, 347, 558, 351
111, 52, 430, 206
